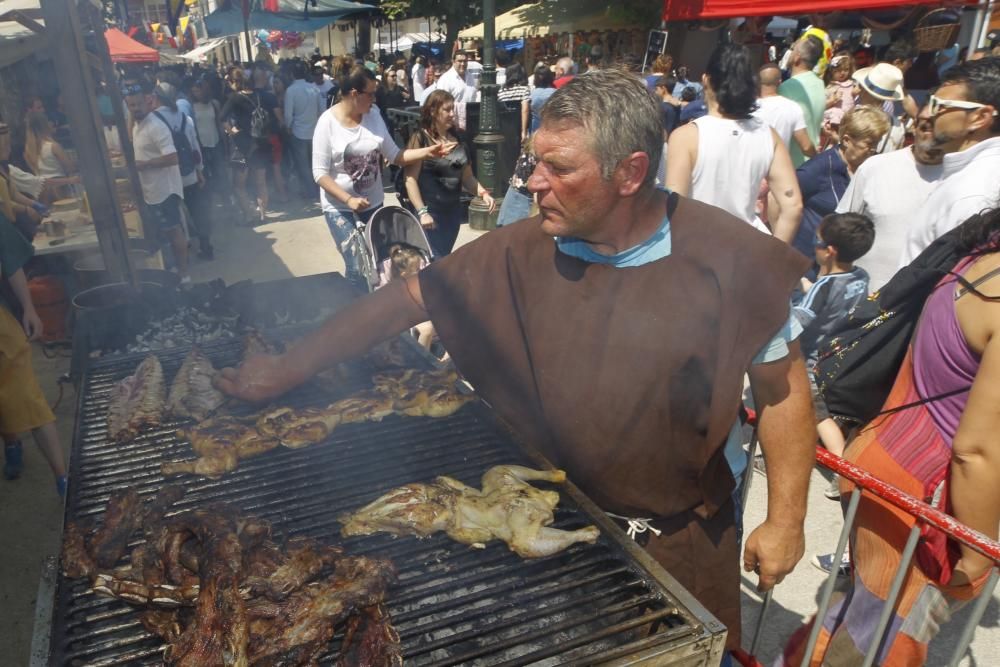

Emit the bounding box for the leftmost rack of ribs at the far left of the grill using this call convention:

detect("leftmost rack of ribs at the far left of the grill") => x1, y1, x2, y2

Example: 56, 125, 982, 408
108, 354, 166, 442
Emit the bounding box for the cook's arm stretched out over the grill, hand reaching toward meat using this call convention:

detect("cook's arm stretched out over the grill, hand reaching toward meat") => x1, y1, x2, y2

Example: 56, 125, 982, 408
215, 277, 428, 403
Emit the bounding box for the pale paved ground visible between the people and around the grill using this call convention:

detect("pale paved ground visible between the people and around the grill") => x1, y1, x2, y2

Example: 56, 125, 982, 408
0, 200, 1000, 666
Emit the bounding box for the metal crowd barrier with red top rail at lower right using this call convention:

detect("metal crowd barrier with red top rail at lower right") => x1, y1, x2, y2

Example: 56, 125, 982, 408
732, 438, 1000, 667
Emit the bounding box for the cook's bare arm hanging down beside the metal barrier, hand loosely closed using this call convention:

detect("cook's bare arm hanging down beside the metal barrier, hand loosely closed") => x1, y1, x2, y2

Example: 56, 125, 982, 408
743, 341, 817, 591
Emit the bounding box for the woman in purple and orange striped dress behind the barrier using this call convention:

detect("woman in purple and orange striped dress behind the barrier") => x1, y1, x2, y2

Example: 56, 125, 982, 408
778, 209, 1000, 667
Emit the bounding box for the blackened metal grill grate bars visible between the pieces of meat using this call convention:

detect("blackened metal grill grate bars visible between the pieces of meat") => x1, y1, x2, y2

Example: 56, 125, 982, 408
51, 332, 723, 666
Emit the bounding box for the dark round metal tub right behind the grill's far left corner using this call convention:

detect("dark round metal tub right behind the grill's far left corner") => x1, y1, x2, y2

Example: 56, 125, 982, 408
73, 283, 177, 353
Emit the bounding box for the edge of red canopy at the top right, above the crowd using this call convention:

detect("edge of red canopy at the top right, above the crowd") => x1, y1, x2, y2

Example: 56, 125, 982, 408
663, 0, 976, 21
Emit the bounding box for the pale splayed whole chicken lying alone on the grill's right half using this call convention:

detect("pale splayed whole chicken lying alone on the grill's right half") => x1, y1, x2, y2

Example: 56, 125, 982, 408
339, 466, 600, 558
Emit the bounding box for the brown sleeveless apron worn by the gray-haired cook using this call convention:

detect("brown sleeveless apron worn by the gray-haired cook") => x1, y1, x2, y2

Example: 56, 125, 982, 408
420, 198, 805, 645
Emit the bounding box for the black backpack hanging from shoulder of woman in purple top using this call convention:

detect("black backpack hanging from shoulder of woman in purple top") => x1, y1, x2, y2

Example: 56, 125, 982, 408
814, 215, 979, 424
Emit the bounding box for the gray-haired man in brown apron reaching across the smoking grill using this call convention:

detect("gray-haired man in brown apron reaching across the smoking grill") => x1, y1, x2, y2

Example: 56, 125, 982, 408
219, 70, 816, 648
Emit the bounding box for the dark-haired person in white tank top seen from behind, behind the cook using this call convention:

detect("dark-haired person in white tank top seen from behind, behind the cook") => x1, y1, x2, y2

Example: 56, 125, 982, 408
667, 44, 802, 243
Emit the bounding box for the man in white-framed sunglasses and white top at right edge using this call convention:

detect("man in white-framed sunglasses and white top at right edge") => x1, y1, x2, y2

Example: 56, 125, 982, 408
900, 58, 1000, 267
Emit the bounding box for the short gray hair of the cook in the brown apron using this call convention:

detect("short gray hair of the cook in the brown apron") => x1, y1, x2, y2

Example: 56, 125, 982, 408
541, 69, 663, 188
